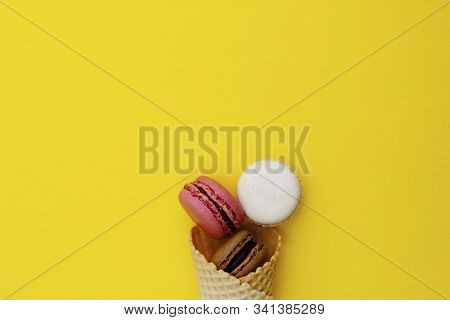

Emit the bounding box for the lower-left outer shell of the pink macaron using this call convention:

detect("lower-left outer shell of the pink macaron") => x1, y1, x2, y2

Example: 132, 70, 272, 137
179, 189, 228, 239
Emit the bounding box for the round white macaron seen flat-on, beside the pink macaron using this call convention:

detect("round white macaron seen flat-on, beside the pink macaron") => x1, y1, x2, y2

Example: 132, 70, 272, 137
237, 160, 302, 226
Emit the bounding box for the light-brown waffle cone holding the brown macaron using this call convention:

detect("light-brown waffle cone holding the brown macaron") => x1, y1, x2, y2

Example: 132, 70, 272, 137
190, 225, 281, 300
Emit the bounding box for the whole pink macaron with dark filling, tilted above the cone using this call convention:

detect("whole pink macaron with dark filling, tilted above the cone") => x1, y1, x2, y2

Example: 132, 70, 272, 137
179, 176, 245, 239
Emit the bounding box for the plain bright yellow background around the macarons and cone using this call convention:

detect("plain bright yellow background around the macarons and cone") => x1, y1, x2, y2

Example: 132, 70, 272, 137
0, 0, 450, 299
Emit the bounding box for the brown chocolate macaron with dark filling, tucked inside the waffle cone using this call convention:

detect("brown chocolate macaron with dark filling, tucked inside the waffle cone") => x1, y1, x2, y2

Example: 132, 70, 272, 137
211, 230, 266, 278
